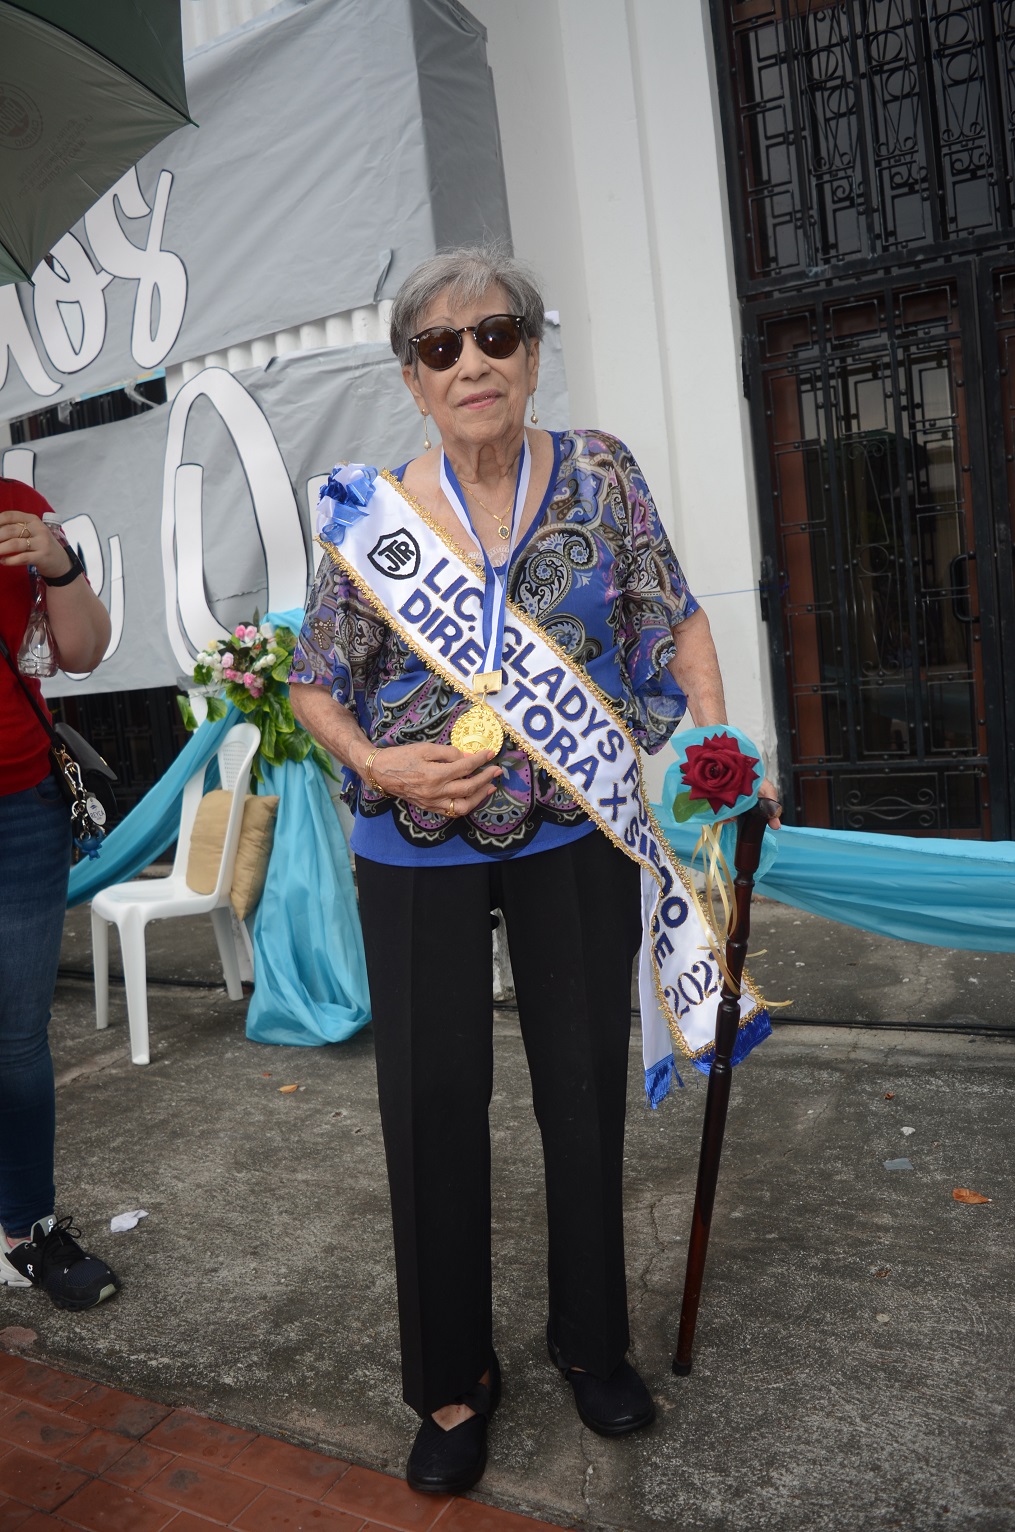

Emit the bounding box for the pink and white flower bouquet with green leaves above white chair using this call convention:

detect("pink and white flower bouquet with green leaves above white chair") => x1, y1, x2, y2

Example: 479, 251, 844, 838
176, 613, 335, 781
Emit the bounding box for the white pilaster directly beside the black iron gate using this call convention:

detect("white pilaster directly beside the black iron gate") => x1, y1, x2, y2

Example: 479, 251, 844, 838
626, 0, 775, 768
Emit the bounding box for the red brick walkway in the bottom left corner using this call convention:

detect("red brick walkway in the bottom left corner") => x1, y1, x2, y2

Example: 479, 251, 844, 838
0, 1351, 559, 1532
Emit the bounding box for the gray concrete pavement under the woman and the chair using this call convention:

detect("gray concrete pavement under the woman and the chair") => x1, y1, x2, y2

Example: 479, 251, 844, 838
0, 902, 1015, 1532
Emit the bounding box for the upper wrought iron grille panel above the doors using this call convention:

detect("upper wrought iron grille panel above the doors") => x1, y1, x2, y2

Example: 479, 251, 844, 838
720, 0, 1015, 291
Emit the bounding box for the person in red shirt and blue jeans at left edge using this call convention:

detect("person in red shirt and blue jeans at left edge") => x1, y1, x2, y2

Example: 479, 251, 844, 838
0, 478, 119, 1308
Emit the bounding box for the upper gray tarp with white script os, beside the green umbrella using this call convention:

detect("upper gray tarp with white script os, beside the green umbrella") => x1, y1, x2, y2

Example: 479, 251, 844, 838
0, 0, 510, 418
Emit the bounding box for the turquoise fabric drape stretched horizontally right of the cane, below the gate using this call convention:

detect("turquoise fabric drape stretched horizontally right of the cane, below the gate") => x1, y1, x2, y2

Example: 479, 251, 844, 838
655, 766, 1015, 953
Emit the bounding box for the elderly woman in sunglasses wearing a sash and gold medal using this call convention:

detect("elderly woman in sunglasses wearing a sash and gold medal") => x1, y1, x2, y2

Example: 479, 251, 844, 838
291, 250, 774, 1492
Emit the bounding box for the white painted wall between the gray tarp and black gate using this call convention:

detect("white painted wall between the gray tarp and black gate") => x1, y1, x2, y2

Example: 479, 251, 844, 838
467, 0, 775, 792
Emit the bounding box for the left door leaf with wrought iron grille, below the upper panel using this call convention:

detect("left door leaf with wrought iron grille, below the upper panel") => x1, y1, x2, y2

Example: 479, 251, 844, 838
756, 279, 989, 836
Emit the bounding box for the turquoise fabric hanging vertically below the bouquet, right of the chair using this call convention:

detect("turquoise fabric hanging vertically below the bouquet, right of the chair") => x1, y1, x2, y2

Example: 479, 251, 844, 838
246, 758, 370, 1046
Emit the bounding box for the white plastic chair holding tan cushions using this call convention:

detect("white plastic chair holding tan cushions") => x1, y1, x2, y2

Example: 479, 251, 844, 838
92, 723, 260, 1063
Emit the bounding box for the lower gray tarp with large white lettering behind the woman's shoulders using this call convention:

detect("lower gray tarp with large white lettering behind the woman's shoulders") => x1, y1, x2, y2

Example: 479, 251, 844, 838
0, 325, 570, 696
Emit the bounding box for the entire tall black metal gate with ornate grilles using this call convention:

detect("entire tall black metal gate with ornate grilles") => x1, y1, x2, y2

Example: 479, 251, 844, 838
713, 0, 1015, 838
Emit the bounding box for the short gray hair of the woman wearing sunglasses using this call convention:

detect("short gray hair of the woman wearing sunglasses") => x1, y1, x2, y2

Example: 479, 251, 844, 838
392, 245, 545, 368
